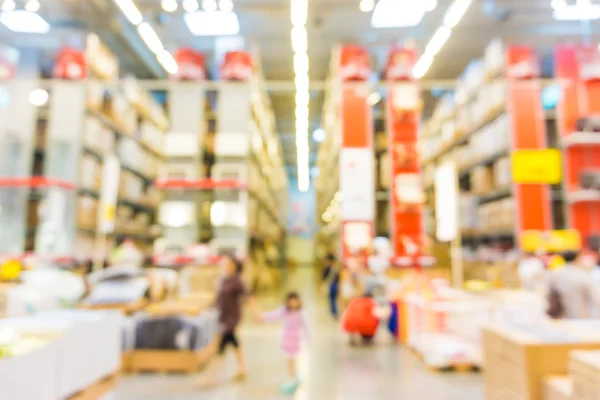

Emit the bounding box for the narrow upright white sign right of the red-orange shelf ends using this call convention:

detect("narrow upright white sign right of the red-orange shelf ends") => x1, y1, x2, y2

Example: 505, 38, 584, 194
435, 162, 458, 242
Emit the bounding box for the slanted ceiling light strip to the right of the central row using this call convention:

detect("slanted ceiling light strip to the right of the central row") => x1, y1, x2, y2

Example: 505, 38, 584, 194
413, 0, 473, 79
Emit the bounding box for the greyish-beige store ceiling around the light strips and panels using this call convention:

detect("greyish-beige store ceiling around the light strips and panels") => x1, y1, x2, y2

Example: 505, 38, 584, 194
0, 0, 599, 175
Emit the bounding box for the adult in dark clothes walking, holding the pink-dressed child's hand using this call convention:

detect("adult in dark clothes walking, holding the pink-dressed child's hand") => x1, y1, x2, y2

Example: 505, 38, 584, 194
202, 256, 256, 387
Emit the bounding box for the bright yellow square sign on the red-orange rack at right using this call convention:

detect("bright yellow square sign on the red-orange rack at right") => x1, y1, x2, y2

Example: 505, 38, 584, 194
512, 149, 562, 185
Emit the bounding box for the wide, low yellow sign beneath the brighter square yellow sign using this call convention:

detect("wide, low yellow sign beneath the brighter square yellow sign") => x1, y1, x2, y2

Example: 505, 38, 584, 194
519, 229, 581, 253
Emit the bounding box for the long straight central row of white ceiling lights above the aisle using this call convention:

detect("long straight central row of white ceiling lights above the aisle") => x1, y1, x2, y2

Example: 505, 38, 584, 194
290, 0, 310, 192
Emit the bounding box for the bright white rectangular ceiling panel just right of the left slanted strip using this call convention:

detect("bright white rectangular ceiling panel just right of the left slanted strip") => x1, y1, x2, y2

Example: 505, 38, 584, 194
183, 11, 240, 36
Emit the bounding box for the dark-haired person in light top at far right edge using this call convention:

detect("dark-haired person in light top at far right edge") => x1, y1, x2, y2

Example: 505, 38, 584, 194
548, 251, 594, 319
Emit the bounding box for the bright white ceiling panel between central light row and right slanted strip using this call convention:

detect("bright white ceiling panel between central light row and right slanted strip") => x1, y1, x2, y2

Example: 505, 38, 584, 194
371, 0, 425, 28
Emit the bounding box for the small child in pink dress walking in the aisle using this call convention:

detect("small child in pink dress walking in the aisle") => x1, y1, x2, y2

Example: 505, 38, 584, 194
262, 292, 309, 393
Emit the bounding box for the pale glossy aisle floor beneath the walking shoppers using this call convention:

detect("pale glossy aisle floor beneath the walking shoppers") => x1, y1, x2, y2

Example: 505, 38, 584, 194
118, 270, 483, 400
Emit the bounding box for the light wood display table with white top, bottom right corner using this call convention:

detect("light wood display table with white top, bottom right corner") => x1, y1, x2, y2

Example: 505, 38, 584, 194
483, 320, 600, 400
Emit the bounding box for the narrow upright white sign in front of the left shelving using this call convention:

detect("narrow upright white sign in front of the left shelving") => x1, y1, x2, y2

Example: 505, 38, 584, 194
98, 156, 121, 233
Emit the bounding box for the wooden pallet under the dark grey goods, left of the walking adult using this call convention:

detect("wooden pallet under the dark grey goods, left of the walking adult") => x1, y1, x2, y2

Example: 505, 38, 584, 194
127, 341, 217, 374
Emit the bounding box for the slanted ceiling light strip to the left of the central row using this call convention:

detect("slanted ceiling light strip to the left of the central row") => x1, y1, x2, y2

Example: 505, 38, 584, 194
114, 0, 179, 74
